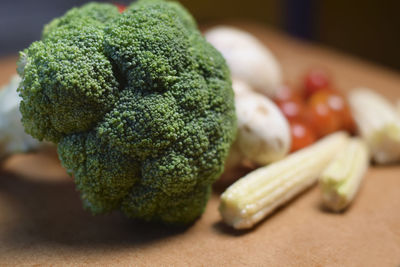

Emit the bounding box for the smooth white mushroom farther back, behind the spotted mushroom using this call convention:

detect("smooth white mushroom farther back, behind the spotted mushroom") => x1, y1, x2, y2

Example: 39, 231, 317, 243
205, 26, 282, 97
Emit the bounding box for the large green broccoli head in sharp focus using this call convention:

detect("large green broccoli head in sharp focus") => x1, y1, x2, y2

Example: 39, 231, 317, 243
18, 0, 236, 224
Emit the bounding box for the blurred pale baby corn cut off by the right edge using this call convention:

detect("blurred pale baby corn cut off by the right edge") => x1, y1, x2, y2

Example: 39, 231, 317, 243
349, 88, 400, 164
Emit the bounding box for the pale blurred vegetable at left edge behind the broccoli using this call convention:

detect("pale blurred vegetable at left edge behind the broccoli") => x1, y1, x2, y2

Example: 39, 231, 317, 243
0, 75, 39, 159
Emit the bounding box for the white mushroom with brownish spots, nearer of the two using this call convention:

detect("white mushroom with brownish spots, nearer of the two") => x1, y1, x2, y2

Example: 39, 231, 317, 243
233, 79, 291, 166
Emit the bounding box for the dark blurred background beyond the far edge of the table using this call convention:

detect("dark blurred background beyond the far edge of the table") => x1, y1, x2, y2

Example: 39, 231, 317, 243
0, 0, 400, 70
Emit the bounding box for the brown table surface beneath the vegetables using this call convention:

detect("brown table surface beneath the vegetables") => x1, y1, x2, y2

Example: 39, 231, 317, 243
0, 23, 400, 266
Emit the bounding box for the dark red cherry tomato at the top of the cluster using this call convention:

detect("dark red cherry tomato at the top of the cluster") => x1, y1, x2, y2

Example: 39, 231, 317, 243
304, 69, 331, 97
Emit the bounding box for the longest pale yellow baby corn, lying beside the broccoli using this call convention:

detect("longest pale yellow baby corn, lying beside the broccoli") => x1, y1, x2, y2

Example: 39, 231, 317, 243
219, 132, 349, 229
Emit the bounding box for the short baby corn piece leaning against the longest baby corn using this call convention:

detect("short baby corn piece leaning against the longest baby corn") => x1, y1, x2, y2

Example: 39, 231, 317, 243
319, 138, 369, 212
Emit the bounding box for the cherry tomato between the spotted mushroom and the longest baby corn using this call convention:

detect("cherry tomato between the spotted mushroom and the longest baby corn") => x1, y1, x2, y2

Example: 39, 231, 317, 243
290, 121, 317, 152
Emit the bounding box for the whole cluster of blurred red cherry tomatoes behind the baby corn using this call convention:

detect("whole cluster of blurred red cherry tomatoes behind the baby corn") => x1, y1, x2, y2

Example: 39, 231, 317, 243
274, 69, 355, 152
